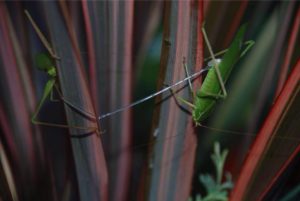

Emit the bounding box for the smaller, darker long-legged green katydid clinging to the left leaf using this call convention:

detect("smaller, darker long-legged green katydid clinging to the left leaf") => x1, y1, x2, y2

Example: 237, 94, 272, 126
25, 10, 98, 133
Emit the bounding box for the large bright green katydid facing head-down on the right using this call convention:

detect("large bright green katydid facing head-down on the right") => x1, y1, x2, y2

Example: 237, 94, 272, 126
172, 25, 254, 125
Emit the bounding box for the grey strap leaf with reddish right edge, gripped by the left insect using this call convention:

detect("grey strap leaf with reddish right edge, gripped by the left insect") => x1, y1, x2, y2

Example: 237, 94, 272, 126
42, 2, 108, 201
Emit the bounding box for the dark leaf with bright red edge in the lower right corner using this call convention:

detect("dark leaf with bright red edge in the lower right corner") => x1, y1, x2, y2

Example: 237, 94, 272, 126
231, 59, 300, 201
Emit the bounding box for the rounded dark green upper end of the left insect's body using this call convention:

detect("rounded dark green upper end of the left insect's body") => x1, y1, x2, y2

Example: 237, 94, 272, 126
35, 53, 56, 77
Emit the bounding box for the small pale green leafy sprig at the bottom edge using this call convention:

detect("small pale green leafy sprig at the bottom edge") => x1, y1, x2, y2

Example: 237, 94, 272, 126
189, 142, 233, 201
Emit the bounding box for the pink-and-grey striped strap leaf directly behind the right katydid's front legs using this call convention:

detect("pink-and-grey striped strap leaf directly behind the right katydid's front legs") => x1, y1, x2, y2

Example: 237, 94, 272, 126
147, 1, 203, 201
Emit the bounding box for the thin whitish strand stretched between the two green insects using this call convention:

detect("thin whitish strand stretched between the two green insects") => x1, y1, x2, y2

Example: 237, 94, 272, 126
98, 62, 212, 120
